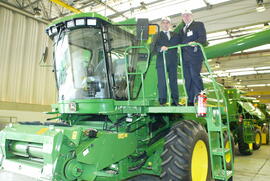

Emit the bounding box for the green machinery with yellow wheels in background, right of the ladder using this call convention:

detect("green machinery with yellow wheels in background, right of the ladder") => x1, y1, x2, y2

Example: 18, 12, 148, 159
225, 89, 270, 155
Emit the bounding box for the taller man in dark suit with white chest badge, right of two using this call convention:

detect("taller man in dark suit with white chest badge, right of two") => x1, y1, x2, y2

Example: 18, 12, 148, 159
181, 10, 207, 106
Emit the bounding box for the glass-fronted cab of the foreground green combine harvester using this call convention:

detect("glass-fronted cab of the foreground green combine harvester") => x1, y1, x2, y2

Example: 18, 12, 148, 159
47, 17, 153, 101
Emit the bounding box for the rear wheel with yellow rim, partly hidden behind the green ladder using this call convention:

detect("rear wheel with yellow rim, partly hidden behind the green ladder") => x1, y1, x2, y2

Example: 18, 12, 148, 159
224, 132, 235, 170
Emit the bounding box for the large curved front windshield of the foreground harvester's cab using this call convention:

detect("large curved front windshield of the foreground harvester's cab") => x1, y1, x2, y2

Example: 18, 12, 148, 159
54, 28, 109, 100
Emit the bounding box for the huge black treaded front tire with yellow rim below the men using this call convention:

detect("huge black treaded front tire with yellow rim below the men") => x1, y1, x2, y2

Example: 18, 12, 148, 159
160, 120, 211, 181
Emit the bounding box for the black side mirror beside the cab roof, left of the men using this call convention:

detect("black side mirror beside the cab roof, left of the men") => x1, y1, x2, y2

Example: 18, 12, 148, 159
136, 18, 149, 40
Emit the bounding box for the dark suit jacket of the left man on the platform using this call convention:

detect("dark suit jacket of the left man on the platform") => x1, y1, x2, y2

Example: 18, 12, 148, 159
153, 31, 180, 67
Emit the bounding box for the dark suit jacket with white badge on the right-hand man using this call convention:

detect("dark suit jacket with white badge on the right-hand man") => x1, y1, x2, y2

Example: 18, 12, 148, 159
181, 21, 207, 61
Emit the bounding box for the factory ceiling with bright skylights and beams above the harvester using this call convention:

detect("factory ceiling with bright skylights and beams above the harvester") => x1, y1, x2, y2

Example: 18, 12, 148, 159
0, 0, 270, 103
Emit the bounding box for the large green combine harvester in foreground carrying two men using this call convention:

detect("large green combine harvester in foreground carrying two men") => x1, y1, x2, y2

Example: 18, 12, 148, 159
0, 13, 270, 181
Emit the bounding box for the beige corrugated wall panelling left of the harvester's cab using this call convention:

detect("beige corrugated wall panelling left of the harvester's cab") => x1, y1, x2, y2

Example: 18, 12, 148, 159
0, 6, 56, 105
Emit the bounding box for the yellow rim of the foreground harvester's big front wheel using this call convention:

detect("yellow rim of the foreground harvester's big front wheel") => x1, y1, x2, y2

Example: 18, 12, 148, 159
191, 140, 208, 181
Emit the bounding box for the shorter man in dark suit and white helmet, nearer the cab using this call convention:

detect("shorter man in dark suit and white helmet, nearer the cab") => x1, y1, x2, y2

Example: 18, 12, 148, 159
154, 17, 180, 106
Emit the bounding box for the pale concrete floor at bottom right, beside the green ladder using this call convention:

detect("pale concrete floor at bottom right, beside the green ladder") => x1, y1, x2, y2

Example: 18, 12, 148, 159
233, 145, 270, 181
